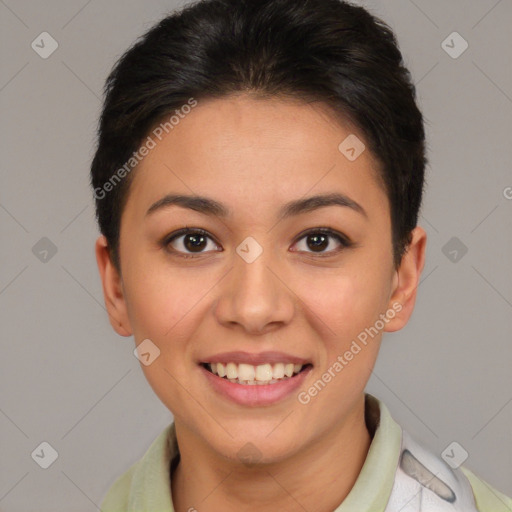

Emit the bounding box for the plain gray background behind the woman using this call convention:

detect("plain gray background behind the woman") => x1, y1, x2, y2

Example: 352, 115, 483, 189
0, 0, 512, 512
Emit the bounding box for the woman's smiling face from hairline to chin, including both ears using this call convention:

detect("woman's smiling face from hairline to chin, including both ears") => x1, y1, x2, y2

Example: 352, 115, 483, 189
96, 96, 425, 461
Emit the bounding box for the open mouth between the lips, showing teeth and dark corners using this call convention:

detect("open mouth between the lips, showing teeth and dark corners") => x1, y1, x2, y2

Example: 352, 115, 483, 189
201, 362, 313, 386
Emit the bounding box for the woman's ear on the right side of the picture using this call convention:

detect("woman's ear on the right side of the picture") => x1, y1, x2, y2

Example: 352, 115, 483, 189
384, 226, 427, 332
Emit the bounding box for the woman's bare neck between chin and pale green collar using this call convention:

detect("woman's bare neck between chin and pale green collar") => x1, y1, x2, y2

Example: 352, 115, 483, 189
171, 395, 371, 512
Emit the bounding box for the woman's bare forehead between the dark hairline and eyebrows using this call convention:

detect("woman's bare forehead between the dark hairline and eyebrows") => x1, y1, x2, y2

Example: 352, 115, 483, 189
126, 95, 387, 223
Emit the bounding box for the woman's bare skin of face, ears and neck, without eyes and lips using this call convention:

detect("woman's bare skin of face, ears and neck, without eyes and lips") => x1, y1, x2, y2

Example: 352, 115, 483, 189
96, 95, 426, 512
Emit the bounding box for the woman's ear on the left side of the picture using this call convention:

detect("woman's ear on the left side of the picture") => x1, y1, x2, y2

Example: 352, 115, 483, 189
95, 235, 132, 336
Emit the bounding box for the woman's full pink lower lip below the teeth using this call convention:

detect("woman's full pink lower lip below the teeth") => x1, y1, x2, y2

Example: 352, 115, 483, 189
199, 365, 312, 406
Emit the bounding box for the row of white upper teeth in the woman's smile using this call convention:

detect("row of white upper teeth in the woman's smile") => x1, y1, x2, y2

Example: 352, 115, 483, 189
208, 363, 302, 382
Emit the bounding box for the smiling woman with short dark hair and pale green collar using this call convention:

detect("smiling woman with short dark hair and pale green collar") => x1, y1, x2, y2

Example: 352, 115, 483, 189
91, 0, 511, 512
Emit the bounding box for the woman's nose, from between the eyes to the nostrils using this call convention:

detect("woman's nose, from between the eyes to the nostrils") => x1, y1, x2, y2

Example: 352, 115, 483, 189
215, 250, 297, 335
